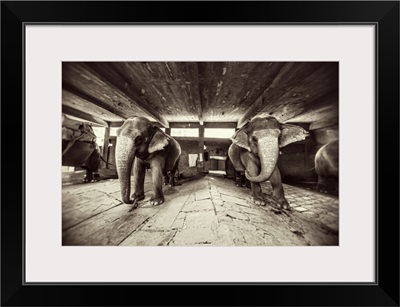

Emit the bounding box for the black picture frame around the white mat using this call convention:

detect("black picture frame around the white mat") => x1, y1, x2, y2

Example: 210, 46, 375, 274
1, 1, 399, 306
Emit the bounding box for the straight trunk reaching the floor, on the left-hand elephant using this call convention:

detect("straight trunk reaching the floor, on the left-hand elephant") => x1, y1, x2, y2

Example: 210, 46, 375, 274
115, 138, 136, 204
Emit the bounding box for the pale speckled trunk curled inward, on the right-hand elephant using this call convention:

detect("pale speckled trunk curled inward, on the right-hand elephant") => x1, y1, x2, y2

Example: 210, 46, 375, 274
245, 136, 279, 182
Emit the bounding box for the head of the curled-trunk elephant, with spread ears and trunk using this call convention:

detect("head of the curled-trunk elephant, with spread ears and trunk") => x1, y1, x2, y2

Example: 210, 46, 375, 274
231, 117, 308, 182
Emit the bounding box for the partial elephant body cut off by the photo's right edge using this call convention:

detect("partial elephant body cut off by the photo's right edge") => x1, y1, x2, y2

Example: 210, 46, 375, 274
314, 140, 339, 194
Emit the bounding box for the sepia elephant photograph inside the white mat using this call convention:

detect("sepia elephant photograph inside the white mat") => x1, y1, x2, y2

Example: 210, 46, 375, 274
61, 62, 340, 247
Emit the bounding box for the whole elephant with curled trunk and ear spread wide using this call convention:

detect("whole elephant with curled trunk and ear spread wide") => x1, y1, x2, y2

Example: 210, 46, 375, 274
228, 116, 308, 209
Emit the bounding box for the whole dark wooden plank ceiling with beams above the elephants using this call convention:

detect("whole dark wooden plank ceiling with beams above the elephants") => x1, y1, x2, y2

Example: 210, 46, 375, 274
62, 62, 339, 127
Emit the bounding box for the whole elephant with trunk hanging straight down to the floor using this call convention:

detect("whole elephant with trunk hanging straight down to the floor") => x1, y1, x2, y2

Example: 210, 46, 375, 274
115, 117, 181, 207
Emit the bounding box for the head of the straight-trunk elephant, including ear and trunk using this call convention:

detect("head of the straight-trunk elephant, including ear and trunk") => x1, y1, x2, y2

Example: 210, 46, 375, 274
115, 117, 170, 204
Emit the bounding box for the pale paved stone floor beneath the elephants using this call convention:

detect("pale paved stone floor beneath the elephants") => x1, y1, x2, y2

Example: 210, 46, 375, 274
62, 174, 339, 246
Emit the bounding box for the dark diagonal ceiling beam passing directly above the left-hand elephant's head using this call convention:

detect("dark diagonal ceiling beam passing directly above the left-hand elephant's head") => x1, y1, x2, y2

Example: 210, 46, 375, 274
82, 63, 169, 128
